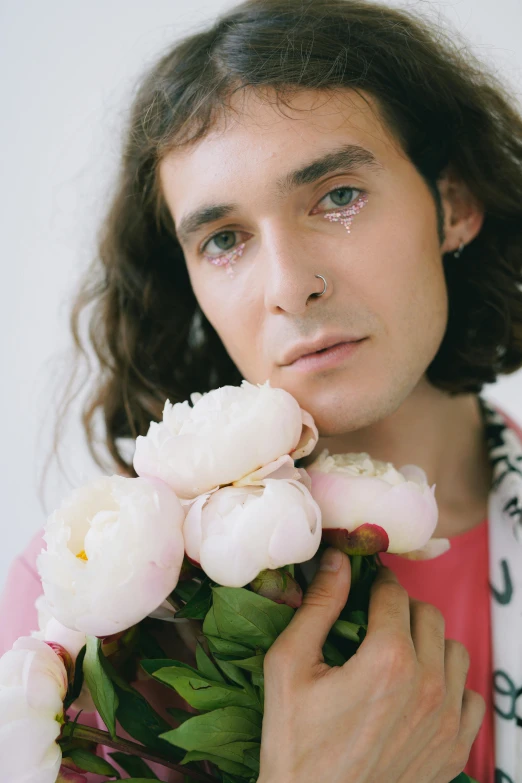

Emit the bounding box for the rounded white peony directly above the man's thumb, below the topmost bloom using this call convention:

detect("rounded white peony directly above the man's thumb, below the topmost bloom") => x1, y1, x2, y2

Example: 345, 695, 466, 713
183, 479, 321, 587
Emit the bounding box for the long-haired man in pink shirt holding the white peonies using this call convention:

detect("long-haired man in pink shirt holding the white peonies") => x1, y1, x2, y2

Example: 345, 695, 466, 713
2, 0, 522, 783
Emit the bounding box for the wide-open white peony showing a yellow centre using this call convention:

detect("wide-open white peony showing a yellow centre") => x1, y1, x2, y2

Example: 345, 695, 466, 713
37, 475, 184, 636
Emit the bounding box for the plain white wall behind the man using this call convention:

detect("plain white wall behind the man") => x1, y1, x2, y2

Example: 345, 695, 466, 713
0, 0, 522, 588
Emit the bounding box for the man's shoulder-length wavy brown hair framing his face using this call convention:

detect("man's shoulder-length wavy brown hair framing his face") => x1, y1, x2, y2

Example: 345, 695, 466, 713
43, 0, 522, 494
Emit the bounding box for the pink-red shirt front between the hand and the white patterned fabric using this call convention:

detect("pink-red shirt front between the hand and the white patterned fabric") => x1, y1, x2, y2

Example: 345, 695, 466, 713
380, 519, 495, 783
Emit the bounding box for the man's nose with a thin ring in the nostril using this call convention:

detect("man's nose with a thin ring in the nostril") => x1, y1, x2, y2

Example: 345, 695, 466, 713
262, 231, 332, 315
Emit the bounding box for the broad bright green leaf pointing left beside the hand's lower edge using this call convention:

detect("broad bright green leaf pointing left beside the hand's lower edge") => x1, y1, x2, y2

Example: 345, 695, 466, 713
161, 707, 263, 755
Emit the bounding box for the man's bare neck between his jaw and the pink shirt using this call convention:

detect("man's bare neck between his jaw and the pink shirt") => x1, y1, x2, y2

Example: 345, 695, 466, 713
301, 381, 492, 538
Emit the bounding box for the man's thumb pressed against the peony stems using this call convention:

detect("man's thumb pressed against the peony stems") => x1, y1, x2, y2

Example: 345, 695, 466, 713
272, 547, 351, 669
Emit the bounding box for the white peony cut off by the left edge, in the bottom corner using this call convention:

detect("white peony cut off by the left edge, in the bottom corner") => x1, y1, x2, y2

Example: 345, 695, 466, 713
0, 636, 67, 783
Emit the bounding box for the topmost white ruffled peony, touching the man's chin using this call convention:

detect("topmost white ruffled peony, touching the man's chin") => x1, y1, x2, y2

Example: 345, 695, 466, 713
134, 381, 318, 499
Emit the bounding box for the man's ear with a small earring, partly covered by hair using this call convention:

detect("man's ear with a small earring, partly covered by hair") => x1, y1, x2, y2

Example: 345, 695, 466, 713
437, 166, 485, 253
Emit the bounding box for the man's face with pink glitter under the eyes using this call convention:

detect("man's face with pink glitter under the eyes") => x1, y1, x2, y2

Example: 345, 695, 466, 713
160, 89, 448, 435
